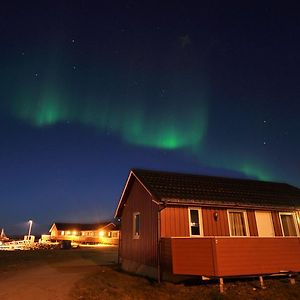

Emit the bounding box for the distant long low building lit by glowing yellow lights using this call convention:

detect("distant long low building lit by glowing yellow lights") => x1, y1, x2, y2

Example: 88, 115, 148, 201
42, 222, 119, 244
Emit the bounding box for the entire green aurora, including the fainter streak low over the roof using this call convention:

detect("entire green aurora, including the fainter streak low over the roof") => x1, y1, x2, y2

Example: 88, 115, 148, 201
12, 89, 273, 180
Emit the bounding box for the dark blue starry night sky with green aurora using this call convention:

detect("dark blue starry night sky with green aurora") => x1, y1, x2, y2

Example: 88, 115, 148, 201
0, 0, 300, 235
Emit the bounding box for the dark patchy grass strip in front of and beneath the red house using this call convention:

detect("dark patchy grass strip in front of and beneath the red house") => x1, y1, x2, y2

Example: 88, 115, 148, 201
72, 266, 300, 300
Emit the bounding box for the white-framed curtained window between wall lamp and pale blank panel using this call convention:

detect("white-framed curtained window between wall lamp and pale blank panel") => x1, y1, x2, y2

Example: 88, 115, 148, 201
228, 210, 249, 236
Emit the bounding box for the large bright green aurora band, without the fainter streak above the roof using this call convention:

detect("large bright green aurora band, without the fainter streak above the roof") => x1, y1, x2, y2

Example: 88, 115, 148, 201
13, 86, 208, 149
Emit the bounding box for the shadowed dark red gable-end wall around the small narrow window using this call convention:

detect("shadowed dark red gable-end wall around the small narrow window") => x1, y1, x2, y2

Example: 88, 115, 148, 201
120, 179, 158, 266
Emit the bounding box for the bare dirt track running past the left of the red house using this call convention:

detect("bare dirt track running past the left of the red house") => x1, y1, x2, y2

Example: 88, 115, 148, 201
0, 247, 117, 300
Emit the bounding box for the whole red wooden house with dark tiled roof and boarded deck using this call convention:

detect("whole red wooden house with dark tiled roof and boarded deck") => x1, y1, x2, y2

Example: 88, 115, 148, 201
115, 170, 300, 278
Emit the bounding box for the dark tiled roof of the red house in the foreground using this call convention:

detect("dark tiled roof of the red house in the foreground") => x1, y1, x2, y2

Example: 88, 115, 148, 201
132, 169, 300, 207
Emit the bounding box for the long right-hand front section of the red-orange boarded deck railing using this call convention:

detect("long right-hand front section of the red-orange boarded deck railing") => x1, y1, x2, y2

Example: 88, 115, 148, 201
217, 238, 300, 276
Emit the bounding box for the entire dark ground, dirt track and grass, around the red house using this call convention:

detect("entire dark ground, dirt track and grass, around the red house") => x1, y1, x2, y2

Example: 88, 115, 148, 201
0, 246, 300, 300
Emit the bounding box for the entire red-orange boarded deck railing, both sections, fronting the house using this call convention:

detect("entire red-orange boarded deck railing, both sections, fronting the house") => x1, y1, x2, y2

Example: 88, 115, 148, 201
166, 237, 300, 277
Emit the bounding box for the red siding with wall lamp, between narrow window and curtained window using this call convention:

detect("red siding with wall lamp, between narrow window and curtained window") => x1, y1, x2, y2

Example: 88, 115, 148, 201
202, 207, 229, 236
